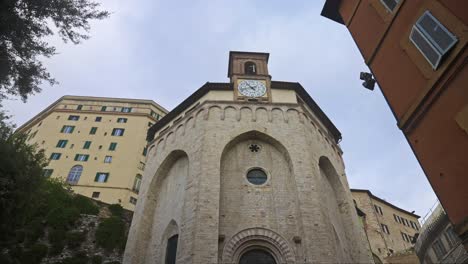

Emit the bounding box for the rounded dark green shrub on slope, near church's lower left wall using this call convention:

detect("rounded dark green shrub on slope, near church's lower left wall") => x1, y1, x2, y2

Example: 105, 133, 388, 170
96, 216, 126, 251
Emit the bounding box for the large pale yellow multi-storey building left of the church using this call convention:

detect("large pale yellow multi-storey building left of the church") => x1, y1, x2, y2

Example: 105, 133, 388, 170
17, 95, 167, 210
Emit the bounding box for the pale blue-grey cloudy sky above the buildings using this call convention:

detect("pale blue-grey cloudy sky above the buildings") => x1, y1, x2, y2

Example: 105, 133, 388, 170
3, 0, 436, 220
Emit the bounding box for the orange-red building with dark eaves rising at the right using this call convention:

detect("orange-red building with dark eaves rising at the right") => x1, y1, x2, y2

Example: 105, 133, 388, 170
322, 0, 468, 248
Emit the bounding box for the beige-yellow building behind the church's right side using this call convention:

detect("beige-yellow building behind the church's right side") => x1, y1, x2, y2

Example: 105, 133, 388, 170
351, 189, 421, 263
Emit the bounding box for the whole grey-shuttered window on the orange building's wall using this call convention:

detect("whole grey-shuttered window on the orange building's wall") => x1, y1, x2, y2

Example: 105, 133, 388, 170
410, 11, 458, 70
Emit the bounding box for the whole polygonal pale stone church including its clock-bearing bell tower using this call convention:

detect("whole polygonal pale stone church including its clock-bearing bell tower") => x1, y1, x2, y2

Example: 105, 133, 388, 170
124, 52, 372, 264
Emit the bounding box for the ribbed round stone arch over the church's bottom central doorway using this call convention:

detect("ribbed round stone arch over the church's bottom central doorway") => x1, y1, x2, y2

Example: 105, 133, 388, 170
222, 228, 295, 264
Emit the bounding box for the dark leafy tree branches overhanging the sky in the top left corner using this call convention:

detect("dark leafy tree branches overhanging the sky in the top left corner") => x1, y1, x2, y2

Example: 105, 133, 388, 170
0, 0, 109, 101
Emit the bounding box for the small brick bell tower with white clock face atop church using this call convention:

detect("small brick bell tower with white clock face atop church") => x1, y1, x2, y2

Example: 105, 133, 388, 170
228, 51, 271, 102
